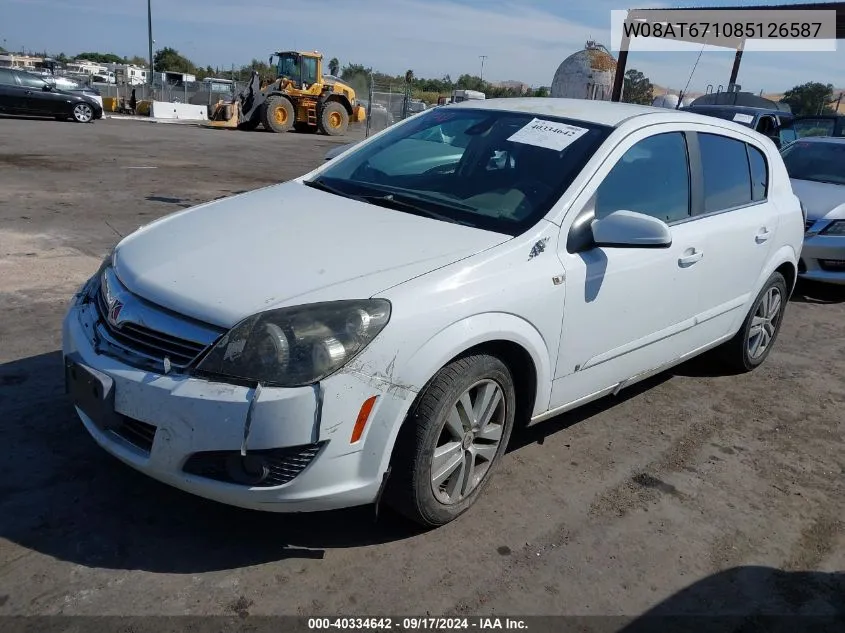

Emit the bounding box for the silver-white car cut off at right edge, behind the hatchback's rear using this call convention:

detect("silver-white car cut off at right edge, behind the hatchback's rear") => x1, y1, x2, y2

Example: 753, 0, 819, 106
782, 136, 845, 284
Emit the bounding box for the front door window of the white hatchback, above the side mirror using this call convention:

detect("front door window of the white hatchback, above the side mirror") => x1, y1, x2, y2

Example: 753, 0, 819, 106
596, 132, 688, 222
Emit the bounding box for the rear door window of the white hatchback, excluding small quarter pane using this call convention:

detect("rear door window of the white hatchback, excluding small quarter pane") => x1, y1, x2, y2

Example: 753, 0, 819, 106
698, 134, 751, 213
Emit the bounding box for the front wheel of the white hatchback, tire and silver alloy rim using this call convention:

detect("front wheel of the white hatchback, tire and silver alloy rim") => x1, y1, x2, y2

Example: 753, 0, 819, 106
384, 354, 516, 527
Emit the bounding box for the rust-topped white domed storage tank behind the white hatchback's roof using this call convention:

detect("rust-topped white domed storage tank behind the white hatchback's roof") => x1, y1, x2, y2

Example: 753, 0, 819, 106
550, 41, 616, 101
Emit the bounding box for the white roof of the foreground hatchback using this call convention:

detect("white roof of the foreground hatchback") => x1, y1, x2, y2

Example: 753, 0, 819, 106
440, 97, 760, 132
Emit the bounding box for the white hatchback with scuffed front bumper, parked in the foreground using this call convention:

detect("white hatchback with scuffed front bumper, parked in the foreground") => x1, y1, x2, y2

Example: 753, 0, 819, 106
63, 99, 804, 526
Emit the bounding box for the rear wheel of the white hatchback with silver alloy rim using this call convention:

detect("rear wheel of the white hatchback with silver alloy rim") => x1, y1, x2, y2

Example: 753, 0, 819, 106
717, 272, 789, 373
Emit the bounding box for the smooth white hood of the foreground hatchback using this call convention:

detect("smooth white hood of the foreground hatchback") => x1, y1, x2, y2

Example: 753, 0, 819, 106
114, 181, 511, 327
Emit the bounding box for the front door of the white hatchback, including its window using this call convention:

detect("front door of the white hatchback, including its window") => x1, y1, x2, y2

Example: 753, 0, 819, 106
550, 126, 707, 408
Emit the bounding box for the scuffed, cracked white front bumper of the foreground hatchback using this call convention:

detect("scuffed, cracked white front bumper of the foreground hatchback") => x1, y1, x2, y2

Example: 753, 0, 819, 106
62, 288, 414, 512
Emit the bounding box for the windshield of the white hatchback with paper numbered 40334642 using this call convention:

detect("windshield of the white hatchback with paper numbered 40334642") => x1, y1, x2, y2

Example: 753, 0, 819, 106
310, 108, 612, 235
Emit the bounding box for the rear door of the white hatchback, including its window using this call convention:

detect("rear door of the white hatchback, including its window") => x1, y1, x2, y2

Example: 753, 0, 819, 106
691, 131, 779, 340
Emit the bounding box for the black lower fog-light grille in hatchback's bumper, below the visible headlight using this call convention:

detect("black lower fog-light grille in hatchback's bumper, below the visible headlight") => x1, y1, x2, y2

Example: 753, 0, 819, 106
182, 442, 325, 488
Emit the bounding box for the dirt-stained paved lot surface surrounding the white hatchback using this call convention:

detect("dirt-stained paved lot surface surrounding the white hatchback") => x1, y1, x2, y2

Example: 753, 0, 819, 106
0, 118, 845, 616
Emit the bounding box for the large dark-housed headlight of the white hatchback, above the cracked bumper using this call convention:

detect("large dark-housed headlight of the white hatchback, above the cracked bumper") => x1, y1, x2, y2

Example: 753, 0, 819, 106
197, 299, 390, 387
